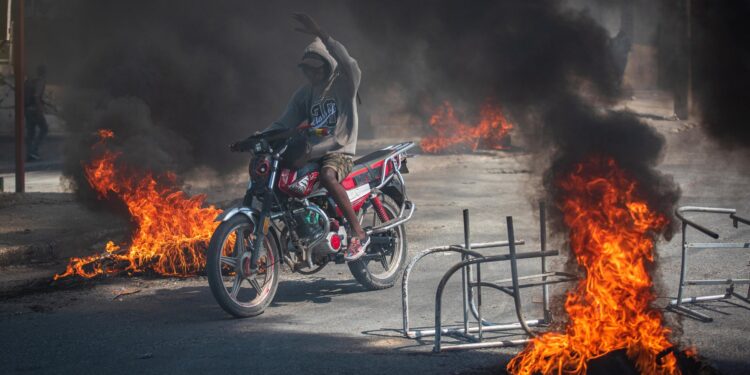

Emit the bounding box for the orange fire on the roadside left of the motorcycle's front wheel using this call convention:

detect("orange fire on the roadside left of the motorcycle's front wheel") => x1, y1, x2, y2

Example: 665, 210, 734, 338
55, 129, 221, 280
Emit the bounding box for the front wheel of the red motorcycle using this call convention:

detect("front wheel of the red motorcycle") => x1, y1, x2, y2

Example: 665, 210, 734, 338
206, 214, 281, 318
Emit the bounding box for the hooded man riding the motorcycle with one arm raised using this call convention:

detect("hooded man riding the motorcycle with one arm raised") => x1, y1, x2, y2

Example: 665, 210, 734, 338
232, 13, 370, 261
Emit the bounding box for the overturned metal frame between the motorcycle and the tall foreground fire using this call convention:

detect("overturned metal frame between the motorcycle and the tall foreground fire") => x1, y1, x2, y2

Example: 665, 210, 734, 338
401, 203, 576, 352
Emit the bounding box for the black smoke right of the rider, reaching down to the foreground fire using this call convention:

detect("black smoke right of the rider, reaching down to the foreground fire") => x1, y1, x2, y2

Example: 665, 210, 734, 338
353, 0, 679, 232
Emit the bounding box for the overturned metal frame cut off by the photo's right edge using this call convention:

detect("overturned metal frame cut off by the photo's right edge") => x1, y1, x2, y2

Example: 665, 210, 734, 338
667, 206, 750, 322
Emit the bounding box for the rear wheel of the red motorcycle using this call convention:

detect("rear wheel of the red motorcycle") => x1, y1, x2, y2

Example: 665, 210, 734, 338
348, 195, 407, 290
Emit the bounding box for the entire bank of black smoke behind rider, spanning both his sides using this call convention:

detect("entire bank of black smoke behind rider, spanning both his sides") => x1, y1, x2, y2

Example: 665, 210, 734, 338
29, 0, 677, 225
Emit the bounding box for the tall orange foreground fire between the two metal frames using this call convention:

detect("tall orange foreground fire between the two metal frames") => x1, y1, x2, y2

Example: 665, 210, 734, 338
508, 157, 679, 374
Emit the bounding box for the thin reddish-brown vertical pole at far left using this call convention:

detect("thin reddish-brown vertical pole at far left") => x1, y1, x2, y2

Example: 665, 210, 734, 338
9, 0, 26, 193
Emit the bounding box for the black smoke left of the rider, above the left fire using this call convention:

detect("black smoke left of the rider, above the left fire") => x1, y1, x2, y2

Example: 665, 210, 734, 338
28, 0, 356, 201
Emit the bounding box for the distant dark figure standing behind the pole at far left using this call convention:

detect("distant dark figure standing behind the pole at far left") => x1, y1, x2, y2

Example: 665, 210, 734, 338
24, 65, 49, 161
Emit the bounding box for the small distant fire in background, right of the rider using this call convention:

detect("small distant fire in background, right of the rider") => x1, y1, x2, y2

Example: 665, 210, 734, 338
421, 101, 513, 153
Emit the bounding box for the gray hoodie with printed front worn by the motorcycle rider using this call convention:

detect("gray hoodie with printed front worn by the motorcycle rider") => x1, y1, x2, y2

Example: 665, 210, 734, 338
267, 37, 362, 158
